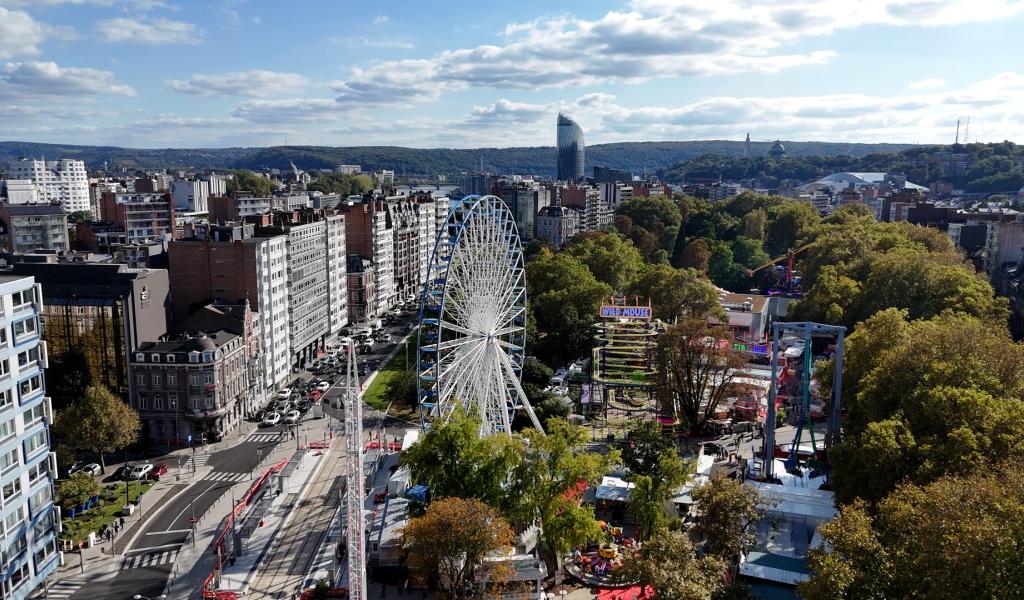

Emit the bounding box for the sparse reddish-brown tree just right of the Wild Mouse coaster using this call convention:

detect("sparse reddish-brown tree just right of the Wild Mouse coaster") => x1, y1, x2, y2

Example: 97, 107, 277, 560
654, 318, 744, 431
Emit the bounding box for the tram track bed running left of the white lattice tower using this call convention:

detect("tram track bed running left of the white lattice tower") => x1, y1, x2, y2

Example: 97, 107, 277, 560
246, 439, 345, 600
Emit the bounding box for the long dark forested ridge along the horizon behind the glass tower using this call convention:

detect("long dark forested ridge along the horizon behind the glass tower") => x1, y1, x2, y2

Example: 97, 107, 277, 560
0, 140, 912, 176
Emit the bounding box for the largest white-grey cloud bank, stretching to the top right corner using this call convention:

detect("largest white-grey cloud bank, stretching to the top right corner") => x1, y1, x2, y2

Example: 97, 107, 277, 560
325, 0, 1024, 103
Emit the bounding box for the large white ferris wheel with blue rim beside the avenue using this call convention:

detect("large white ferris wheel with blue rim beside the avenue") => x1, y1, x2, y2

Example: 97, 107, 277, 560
417, 196, 543, 435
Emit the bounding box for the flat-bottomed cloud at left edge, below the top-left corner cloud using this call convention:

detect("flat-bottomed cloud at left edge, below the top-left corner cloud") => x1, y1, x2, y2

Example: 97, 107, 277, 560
0, 61, 135, 99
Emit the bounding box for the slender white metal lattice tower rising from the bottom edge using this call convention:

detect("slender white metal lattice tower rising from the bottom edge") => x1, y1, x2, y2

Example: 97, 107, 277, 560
343, 342, 367, 600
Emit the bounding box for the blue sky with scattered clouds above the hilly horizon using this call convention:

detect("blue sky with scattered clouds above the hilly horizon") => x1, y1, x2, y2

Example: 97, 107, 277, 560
0, 0, 1024, 147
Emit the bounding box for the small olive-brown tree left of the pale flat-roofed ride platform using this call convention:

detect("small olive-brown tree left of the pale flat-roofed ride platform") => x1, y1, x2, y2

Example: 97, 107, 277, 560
690, 477, 770, 559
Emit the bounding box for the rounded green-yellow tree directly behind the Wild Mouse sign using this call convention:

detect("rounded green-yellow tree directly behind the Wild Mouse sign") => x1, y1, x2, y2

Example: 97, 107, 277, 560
629, 263, 724, 322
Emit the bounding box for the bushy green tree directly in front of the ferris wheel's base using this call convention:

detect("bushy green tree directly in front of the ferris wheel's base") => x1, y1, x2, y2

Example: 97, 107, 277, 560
401, 408, 524, 508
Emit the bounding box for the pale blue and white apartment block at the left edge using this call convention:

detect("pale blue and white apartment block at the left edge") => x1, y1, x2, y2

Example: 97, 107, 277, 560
0, 275, 60, 600
